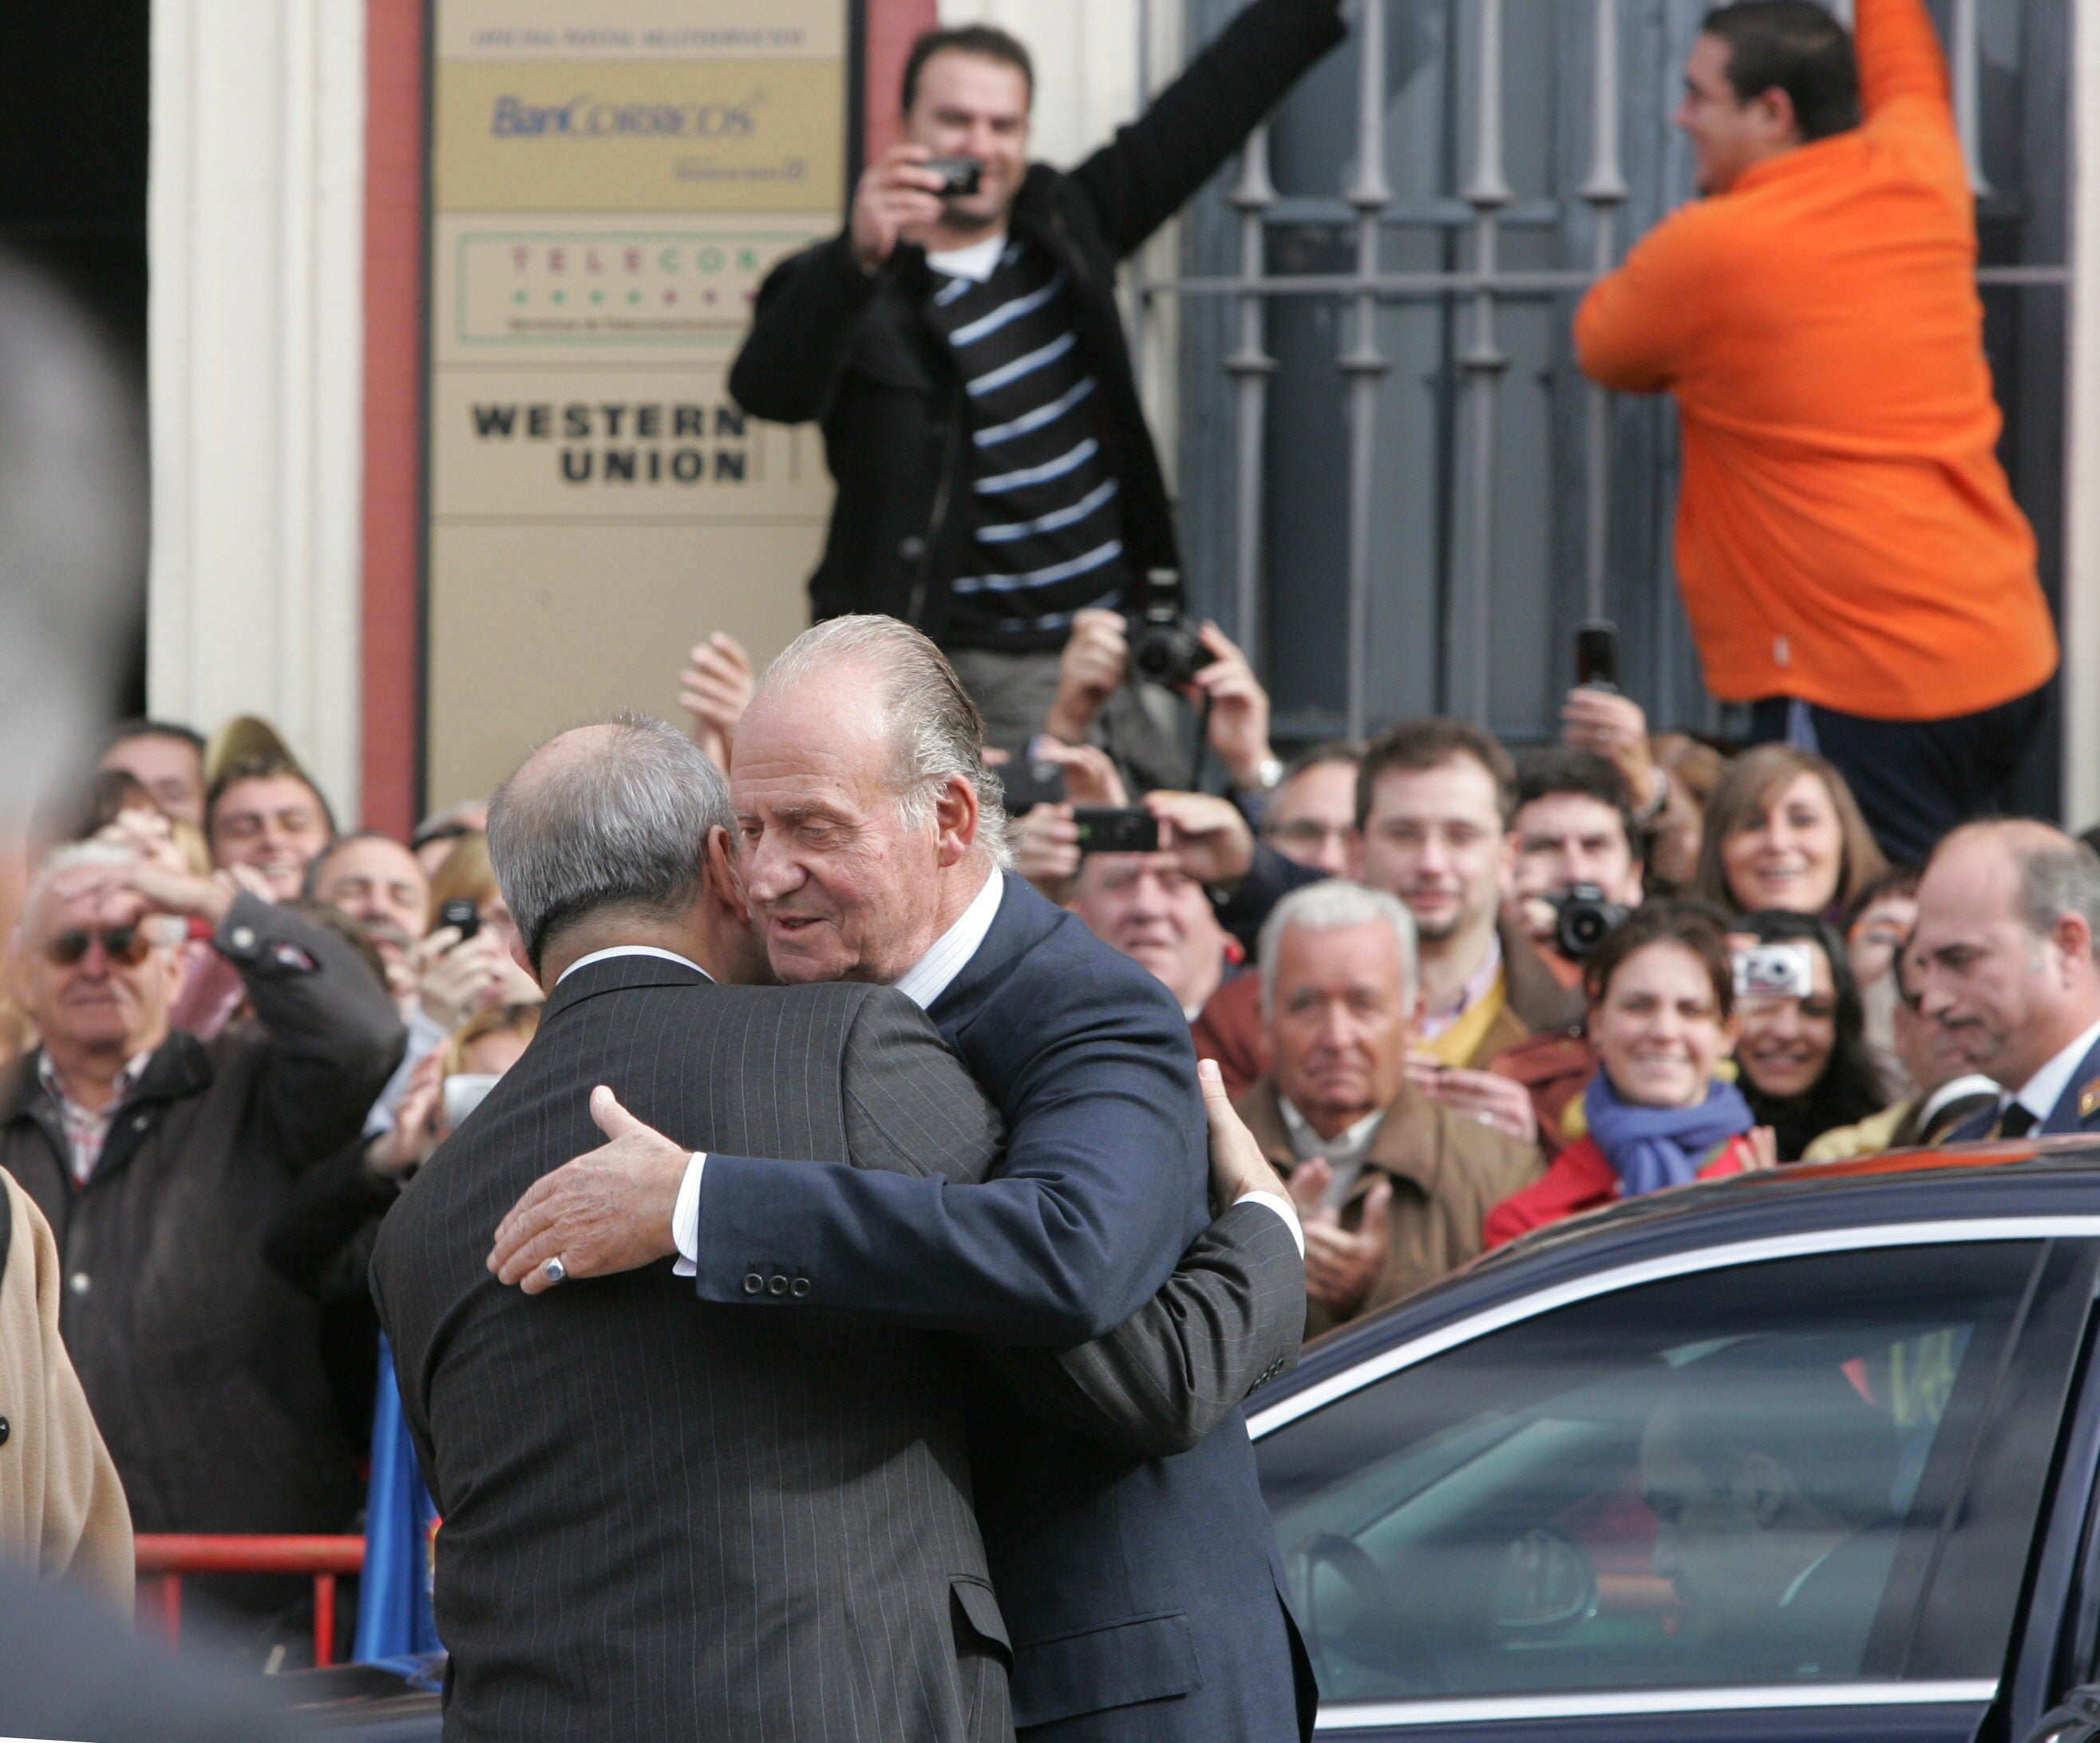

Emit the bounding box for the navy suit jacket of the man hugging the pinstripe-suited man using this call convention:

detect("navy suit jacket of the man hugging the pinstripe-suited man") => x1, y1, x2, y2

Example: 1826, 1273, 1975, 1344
697, 875, 1317, 1743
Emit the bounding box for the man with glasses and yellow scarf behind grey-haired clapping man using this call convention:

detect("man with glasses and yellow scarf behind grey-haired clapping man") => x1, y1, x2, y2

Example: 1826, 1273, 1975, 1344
1195, 721, 1580, 1140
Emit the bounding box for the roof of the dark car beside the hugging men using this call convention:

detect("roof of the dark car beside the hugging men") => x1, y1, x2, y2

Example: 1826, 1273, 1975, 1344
1249, 1134, 2100, 1411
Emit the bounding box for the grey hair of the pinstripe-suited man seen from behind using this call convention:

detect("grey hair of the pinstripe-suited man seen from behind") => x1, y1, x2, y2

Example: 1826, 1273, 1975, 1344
489, 714, 735, 968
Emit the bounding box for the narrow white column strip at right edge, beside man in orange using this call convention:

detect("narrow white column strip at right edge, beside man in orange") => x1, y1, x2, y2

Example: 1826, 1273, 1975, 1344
2064, 0, 2100, 829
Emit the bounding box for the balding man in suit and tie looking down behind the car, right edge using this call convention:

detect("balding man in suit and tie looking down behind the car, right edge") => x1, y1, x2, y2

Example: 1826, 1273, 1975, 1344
1911, 821, 2100, 1140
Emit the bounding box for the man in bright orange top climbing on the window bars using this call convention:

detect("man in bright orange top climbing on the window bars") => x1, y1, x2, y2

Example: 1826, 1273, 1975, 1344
1575, 0, 2056, 863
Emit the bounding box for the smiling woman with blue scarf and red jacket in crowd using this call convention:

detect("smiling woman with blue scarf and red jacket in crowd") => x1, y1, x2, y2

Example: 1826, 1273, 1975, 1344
1485, 903, 1773, 1247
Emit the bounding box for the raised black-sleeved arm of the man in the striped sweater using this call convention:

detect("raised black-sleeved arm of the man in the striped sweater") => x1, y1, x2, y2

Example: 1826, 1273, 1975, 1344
1073, 0, 1346, 254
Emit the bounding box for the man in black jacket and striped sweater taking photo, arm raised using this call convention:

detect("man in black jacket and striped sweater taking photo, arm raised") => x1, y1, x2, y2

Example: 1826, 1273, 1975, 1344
729, 0, 1344, 748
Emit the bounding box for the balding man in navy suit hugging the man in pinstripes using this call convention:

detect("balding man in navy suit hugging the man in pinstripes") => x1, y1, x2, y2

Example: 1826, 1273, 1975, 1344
489, 618, 1315, 1743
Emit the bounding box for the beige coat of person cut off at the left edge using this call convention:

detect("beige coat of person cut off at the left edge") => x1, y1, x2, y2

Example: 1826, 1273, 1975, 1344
0, 1168, 132, 1615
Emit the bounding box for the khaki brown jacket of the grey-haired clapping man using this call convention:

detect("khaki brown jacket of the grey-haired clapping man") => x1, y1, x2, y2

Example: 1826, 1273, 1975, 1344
1235, 1075, 1545, 1338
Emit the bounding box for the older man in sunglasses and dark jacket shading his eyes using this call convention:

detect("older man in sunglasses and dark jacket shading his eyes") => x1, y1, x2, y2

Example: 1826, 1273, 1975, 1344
0, 842, 401, 1654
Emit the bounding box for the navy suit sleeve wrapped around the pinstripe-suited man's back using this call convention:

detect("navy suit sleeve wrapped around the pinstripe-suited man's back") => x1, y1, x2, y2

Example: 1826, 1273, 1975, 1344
697, 951, 1209, 1348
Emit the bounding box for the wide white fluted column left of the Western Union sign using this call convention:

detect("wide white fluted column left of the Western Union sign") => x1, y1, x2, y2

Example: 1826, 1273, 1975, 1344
147, 0, 370, 821
